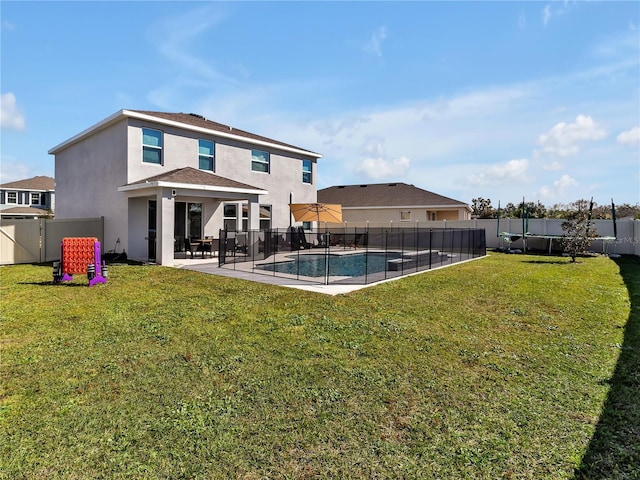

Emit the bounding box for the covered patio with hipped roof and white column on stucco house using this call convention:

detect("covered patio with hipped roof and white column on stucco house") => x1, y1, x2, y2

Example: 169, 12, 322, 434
118, 167, 268, 266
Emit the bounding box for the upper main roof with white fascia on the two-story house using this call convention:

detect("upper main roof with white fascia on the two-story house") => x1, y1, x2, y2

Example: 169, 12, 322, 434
49, 110, 322, 158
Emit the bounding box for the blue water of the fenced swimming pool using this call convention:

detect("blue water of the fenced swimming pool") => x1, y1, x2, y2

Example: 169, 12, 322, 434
256, 253, 400, 277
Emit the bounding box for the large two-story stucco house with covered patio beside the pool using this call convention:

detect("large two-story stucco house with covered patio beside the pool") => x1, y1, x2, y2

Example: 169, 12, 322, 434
49, 110, 321, 265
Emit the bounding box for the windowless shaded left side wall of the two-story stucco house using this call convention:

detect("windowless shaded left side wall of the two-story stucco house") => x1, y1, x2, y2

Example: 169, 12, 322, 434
55, 119, 129, 255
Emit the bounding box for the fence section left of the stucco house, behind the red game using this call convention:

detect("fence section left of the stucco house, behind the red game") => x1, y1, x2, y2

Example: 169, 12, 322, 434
0, 217, 104, 265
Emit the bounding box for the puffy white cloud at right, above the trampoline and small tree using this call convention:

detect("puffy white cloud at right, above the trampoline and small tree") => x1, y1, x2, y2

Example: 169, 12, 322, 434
538, 115, 607, 157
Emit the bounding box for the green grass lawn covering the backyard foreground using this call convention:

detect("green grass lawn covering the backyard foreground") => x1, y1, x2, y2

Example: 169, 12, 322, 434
0, 254, 640, 479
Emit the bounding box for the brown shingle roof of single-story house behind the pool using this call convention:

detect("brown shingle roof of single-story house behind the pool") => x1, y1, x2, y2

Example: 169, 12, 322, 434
318, 183, 470, 209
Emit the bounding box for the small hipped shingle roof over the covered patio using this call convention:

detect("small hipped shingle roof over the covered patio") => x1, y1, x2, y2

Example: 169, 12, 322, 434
119, 167, 268, 195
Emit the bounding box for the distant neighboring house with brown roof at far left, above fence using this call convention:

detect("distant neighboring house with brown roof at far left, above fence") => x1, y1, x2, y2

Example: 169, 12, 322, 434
0, 175, 55, 218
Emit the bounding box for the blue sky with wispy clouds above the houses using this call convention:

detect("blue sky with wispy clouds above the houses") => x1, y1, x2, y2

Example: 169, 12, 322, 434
0, 0, 640, 206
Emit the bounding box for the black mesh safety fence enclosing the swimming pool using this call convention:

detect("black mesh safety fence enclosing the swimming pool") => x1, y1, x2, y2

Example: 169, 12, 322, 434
218, 227, 487, 285
